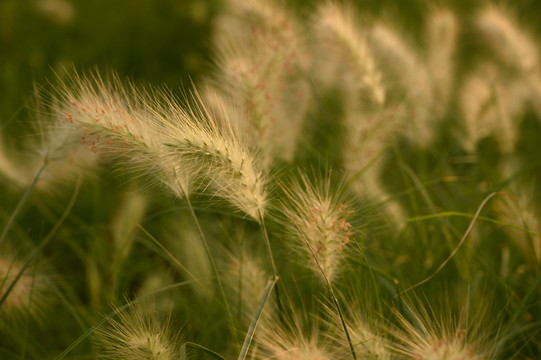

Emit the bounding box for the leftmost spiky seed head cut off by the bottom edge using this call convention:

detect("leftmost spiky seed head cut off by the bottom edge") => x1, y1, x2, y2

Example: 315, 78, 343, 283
99, 305, 179, 360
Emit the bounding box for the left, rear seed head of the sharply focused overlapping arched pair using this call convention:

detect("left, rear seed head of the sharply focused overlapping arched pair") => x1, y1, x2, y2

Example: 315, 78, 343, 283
57, 71, 191, 197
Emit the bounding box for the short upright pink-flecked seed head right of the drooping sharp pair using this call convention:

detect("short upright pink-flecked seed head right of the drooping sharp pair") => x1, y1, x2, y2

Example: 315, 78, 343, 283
284, 174, 354, 281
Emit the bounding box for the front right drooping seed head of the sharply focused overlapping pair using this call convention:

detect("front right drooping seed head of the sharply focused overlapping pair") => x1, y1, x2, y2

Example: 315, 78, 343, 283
160, 92, 267, 221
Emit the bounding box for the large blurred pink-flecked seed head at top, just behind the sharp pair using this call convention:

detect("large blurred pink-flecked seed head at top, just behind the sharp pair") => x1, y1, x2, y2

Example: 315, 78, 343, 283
209, 1, 310, 166
